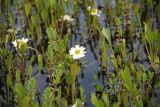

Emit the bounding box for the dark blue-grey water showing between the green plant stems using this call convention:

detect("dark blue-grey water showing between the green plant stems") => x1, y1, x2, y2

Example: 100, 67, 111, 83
0, 0, 160, 107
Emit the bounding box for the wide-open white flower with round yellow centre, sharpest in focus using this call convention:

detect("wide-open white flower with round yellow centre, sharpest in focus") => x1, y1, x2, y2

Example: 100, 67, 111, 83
69, 45, 86, 59
